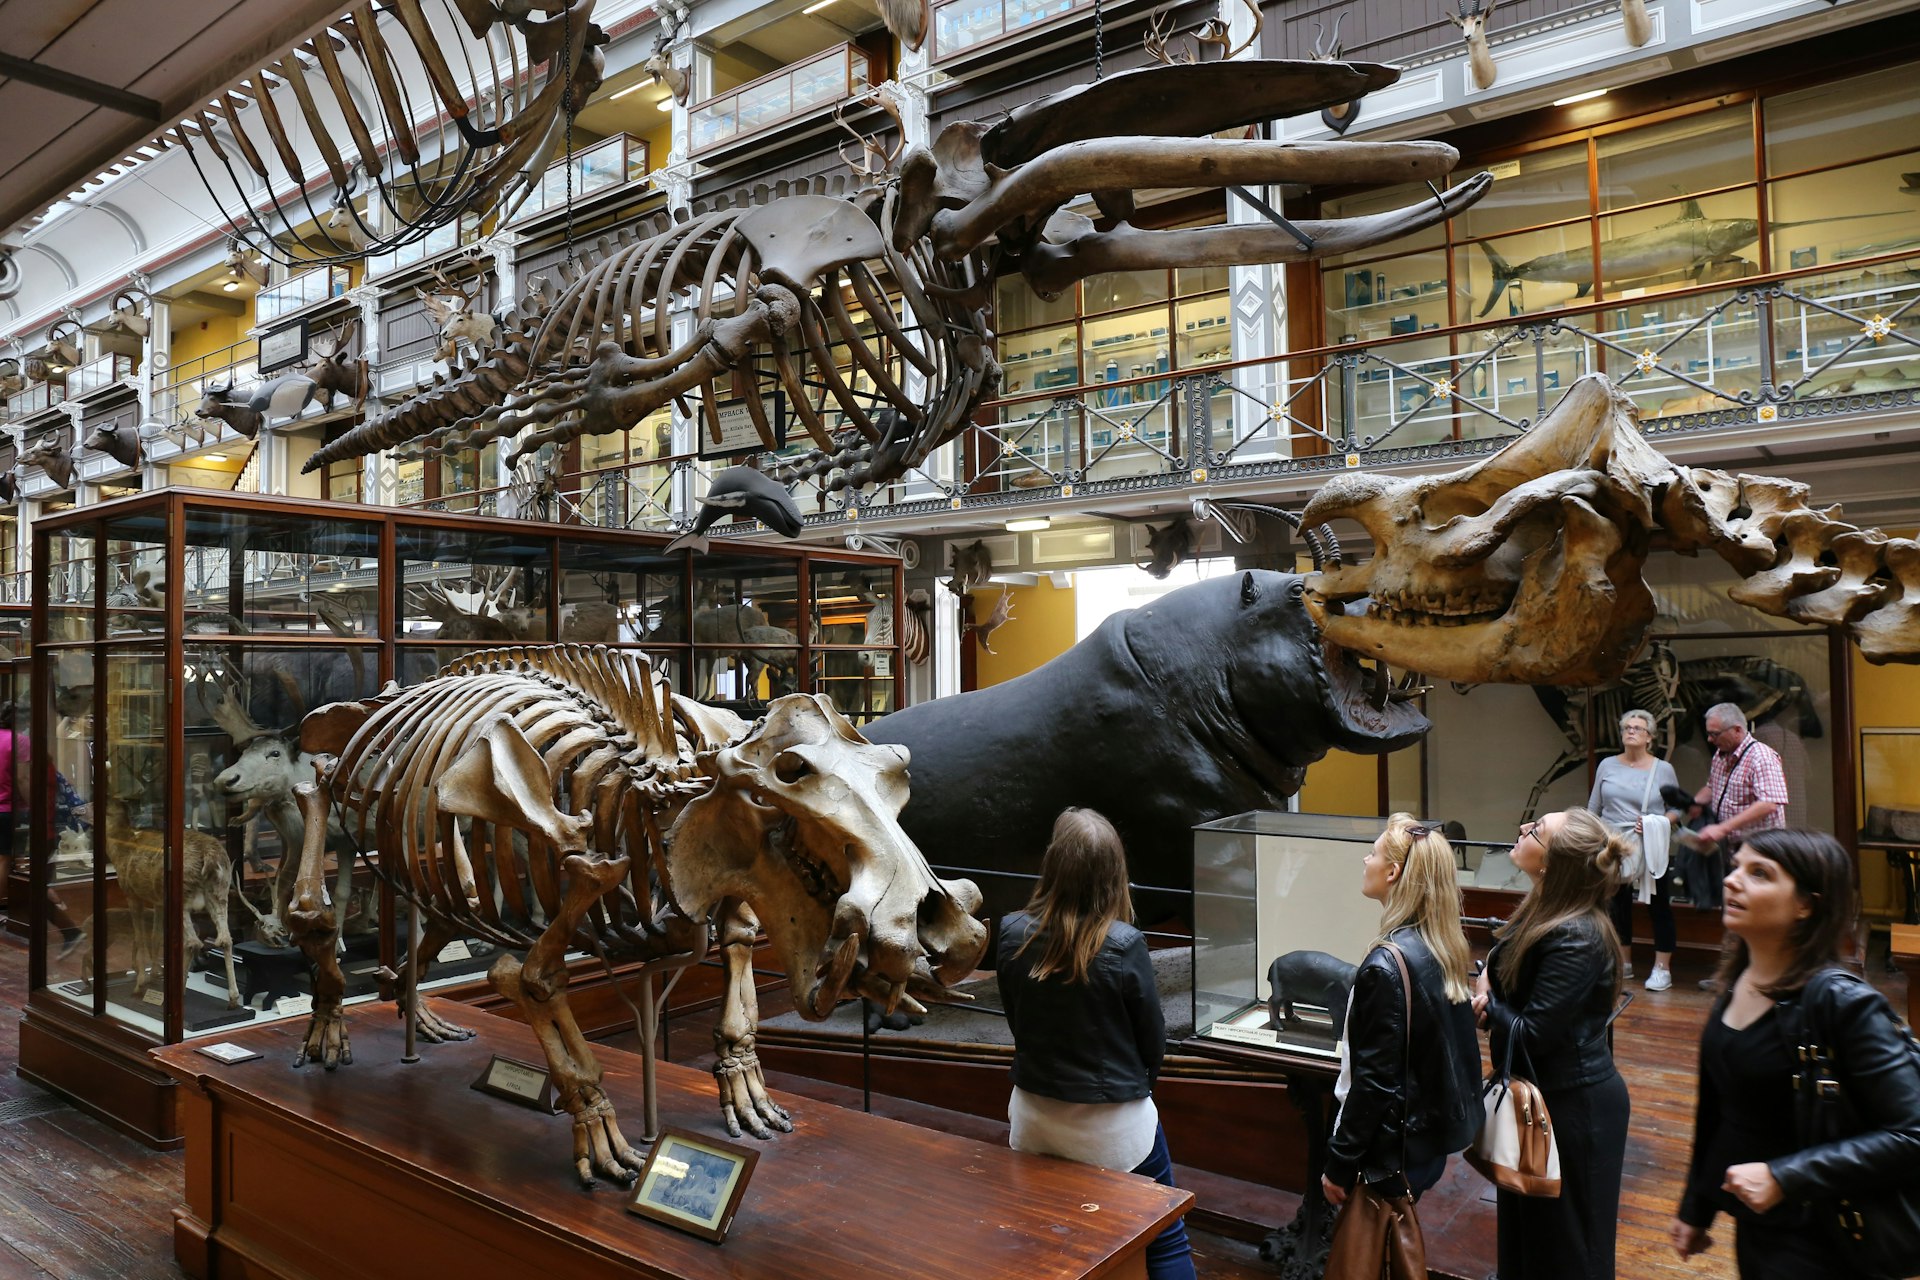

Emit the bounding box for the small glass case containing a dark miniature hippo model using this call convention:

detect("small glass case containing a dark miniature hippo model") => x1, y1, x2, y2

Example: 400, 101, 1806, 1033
1194, 812, 1386, 1061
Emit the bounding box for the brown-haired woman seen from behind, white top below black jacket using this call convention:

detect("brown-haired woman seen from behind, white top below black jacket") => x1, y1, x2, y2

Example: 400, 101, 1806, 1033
998, 808, 1194, 1280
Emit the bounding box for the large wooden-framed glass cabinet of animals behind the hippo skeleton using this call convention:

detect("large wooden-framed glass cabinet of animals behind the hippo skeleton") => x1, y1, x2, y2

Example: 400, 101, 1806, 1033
19, 489, 904, 1144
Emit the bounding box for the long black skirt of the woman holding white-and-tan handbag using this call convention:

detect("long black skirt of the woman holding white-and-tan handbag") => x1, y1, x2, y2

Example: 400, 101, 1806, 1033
1500, 1071, 1632, 1280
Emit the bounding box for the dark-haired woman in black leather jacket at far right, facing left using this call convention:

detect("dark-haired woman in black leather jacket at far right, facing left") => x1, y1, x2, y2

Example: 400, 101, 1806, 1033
1672, 827, 1920, 1280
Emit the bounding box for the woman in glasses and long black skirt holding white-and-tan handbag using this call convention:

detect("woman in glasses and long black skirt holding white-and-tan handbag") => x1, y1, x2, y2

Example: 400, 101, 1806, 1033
1475, 808, 1630, 1280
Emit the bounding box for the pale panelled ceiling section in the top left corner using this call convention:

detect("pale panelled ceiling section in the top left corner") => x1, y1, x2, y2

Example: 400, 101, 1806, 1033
0, 0, 348, 232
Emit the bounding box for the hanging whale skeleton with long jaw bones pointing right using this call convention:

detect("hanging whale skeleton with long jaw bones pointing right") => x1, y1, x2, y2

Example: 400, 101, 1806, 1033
307, 59, 1492, 491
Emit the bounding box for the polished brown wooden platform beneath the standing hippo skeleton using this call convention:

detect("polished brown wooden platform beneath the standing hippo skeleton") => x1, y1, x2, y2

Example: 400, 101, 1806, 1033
154, 1000, 1190, 1280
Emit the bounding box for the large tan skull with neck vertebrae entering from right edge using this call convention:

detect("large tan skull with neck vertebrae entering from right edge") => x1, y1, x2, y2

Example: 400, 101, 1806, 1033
1302, 376, 1920, 685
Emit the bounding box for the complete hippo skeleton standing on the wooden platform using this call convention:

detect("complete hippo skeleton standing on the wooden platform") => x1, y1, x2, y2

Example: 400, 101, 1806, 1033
286, 645, 987, 1184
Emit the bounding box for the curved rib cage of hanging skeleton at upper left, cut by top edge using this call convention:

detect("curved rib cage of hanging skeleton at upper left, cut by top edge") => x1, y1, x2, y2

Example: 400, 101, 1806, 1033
173, 0, 607, 265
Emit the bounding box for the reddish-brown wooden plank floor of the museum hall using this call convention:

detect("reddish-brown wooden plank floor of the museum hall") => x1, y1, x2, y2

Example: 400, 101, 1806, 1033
0, 921, 1905, 1280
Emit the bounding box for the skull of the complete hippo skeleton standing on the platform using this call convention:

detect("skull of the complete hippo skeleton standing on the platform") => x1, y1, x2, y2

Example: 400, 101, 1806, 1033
668, 695, 987, 1019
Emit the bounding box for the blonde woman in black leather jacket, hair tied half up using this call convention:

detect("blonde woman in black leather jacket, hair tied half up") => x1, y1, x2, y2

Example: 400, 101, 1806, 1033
1321, 814, 1480, 1205
